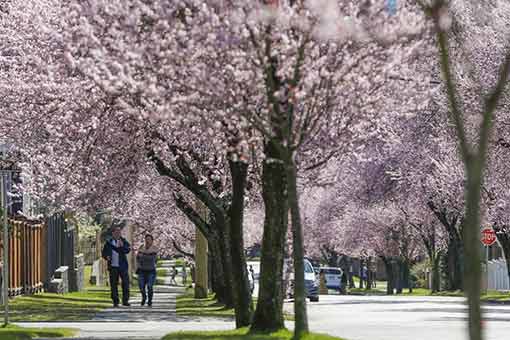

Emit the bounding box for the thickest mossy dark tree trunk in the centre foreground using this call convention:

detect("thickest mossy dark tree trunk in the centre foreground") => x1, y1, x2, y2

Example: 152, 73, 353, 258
251, 143, 288, 332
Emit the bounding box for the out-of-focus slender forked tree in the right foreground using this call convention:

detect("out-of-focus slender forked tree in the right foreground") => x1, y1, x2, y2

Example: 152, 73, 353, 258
419, 0, 510, 340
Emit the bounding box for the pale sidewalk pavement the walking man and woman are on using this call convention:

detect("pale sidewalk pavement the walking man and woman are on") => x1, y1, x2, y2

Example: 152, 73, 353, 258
16, 260, 235, 340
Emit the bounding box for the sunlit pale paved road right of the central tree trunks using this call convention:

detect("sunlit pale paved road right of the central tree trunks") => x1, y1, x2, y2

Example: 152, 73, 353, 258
285, 295, 510, 340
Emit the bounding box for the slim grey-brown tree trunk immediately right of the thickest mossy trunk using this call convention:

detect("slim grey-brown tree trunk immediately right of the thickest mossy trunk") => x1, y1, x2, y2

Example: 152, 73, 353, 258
286, 159, 308, 340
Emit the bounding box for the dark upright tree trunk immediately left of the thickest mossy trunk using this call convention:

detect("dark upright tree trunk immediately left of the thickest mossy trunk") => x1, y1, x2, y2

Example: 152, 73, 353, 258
229, 160, 253, 328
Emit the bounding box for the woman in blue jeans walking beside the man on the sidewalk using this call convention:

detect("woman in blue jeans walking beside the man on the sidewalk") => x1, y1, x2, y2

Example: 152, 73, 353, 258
136, 234, 158, 307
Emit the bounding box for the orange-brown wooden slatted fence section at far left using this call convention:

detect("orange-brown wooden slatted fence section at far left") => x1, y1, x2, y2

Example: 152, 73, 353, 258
9, 220, 45, 296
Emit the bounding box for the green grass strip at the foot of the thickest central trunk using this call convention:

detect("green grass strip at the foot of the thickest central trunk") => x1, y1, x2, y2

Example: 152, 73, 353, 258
162, 328, 341, 340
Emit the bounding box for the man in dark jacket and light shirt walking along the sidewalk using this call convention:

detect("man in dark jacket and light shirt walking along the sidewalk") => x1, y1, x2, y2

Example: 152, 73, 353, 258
102, 226, 131, 307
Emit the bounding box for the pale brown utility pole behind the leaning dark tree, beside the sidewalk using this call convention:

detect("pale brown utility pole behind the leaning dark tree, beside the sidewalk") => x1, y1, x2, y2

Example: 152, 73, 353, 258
195, 202, 208, 299
